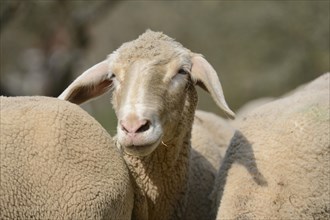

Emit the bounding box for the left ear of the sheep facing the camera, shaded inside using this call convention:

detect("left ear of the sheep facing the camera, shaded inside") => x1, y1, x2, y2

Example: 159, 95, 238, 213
58, 60, 112, 104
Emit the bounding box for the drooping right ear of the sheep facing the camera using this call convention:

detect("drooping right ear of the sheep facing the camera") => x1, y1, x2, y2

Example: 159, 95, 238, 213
191, 54, 235, 118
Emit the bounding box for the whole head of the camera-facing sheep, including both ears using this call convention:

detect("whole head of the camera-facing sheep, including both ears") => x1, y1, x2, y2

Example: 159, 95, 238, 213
59, 30, 234, 156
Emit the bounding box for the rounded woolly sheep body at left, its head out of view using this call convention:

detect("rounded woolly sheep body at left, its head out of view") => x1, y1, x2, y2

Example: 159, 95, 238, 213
0, 96, 134, 220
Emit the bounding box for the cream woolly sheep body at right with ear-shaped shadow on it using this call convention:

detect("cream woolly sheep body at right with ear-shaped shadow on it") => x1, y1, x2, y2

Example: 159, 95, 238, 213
213, 73, 330, 219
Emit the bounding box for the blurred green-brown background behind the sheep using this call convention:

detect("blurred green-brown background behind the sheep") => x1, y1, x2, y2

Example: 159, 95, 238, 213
0, 0, 330, 134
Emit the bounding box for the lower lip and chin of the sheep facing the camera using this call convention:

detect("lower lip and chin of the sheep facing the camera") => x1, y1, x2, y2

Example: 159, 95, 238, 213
122, 137, 161, 157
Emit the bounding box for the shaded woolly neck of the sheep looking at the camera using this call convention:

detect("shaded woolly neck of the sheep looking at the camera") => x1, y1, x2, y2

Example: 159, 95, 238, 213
124, 86, 197, 220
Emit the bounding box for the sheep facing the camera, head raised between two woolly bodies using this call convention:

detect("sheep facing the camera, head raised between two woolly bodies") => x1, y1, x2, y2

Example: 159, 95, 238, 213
58, 30, 234, 220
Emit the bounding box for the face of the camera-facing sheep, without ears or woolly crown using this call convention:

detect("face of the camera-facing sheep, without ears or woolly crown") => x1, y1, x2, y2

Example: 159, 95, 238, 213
110, 49, 197, 156
